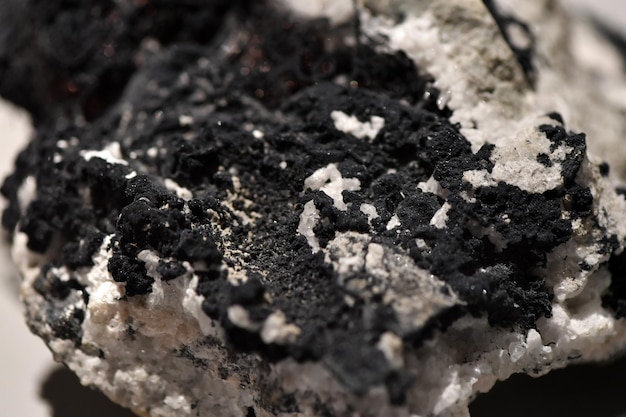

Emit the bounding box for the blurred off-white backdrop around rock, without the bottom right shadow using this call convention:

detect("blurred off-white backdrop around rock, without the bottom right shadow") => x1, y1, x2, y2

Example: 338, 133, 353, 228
0, 0, 626, 417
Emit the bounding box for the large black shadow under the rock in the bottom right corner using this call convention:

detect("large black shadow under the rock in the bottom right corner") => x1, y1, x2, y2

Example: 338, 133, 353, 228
470, 357, 626, 417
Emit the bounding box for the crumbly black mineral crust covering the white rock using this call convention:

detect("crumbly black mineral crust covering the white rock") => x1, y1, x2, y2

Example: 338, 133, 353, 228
0, 1, 604, 411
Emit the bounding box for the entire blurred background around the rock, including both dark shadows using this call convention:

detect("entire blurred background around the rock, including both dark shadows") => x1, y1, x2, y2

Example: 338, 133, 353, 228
0, 0, 626, 417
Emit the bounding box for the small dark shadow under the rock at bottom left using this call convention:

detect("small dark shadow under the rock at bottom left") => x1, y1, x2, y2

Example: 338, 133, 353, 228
39, 366, 137, 417
